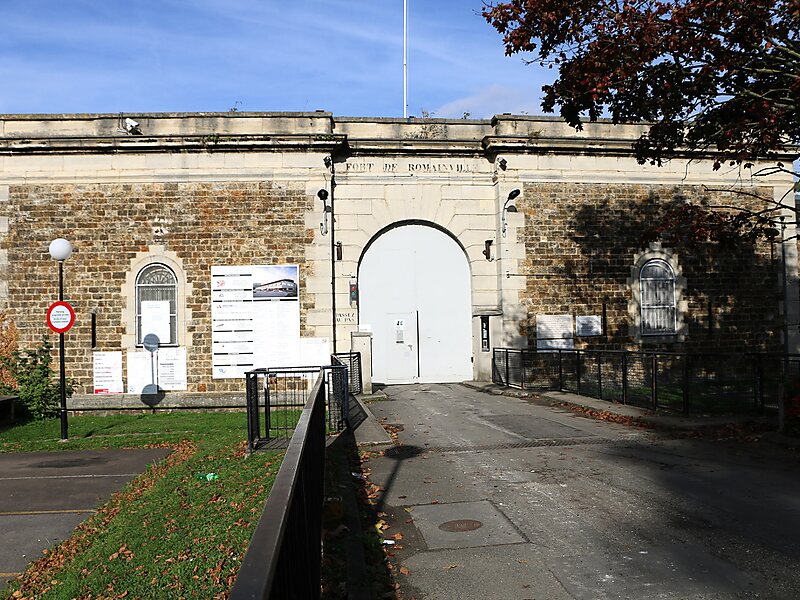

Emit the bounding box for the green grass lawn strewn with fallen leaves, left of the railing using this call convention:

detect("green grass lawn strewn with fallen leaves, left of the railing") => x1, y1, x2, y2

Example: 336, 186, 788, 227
0, 413, 283, 600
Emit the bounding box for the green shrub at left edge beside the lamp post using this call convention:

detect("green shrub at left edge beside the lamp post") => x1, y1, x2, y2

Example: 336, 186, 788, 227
0, 338, 72, 420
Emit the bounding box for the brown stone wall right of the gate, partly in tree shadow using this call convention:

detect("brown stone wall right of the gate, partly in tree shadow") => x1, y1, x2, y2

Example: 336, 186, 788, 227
517, 183, 782, 351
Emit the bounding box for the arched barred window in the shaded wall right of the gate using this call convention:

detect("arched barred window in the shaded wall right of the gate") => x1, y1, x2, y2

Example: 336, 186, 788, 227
639, 259, 676, 335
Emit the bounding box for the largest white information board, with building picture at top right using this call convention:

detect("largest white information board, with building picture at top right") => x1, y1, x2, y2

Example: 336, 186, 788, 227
211, 265, 301, 379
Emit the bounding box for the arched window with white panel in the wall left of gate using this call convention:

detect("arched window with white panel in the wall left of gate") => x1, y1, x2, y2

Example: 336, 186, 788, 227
136, 263, 178, 346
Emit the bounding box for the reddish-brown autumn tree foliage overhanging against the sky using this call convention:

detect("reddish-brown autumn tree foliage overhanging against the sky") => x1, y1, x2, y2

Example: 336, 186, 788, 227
483, 0, 800, 168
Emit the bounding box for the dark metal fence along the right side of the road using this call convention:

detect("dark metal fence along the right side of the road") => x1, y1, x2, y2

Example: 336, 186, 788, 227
492, 348, 800, 414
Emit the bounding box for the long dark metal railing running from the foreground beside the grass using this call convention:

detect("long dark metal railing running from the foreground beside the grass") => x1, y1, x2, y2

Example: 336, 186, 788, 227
230, 372, 327, 600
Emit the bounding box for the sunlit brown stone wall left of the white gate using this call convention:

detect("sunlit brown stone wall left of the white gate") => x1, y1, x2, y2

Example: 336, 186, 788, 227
3, 181, 314, 394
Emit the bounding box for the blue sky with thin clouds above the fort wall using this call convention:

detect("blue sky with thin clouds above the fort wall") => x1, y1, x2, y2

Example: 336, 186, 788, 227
0, 0, 543, 118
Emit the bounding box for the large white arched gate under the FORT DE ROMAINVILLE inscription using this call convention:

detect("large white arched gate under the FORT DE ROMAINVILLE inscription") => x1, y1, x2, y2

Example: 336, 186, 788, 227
358, 224, 472, 383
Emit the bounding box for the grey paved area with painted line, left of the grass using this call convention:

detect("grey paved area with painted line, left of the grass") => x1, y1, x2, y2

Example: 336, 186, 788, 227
0, 448, 169, 588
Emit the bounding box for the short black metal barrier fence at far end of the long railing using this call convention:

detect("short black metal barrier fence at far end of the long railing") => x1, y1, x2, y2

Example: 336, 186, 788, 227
245, 364, 350, 452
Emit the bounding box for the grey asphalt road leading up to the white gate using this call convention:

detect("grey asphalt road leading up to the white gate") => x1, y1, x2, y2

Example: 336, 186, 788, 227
367, 385, 800, 600
